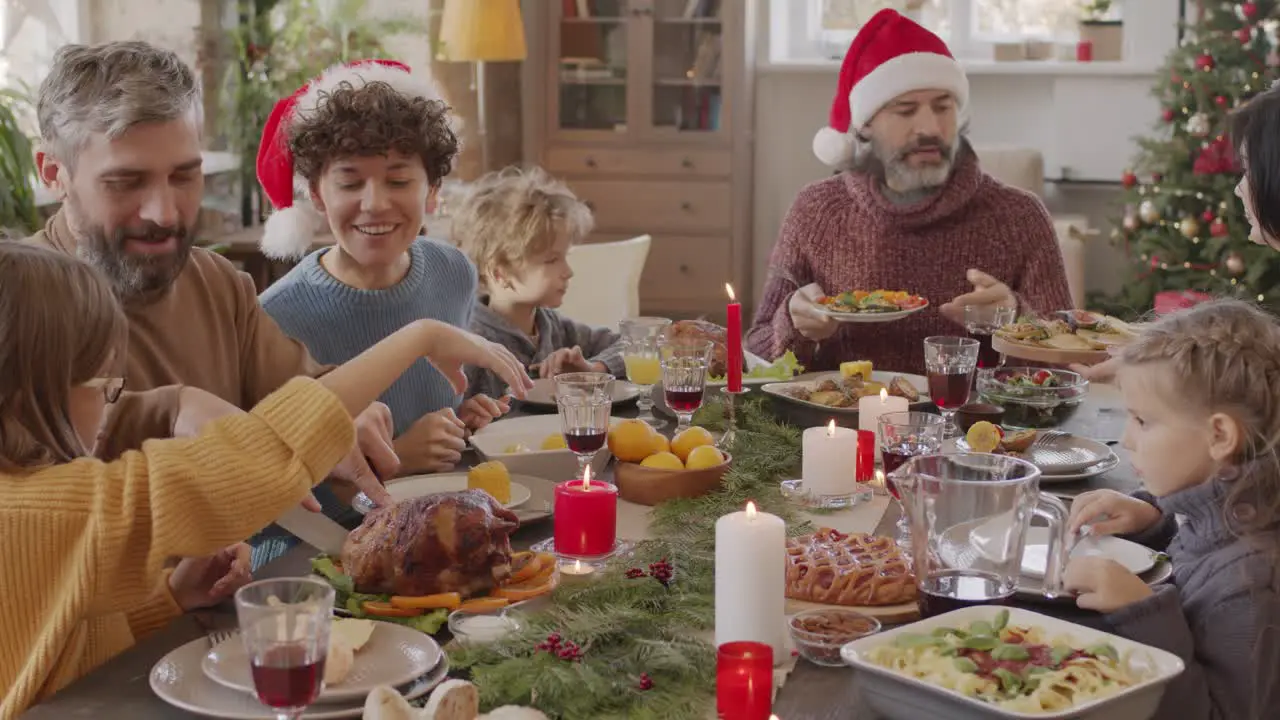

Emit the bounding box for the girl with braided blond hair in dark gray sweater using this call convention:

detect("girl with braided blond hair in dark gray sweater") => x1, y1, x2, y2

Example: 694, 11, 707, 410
1064, 300, 1280, 720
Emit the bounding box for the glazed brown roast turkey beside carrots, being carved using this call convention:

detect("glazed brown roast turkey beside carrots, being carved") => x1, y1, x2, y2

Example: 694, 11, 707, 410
342, 489, 520, 597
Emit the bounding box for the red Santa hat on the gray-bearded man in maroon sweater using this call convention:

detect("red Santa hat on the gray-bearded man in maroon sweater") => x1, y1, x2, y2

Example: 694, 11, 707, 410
813, 9, 969, 168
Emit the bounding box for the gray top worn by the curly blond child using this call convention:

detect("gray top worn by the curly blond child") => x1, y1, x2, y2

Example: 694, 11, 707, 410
467, 297, 627, 397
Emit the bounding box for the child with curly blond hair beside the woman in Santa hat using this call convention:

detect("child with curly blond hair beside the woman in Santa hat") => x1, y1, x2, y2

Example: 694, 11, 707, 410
452, 168, 626, 397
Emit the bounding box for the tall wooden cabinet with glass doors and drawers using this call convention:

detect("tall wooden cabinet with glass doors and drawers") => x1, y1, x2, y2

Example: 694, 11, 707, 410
524, 0, 755, 318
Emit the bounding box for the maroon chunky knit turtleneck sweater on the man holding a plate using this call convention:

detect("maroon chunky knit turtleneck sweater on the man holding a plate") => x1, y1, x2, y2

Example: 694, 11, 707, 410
746, 146, 1071, 373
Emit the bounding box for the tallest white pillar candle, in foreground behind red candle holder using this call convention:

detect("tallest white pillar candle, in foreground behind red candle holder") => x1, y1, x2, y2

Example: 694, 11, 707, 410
716, 502, 787, 664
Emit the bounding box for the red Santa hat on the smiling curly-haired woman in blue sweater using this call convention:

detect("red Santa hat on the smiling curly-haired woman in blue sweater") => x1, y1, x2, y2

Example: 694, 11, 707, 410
257, 60, 443, 260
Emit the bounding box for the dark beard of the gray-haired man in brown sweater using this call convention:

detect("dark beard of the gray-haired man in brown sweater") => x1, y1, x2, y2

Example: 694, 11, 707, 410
77, 223, 193, 300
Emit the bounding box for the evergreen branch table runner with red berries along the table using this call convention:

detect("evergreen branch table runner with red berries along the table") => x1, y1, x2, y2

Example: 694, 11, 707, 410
448, 400, 812, 720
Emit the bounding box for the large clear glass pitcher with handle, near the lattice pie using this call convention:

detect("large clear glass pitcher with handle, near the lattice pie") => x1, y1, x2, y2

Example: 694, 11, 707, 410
893, 452, 1068, 618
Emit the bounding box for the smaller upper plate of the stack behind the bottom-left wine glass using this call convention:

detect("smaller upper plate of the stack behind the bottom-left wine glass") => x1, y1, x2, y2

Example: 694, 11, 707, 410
201, 621, 442, 703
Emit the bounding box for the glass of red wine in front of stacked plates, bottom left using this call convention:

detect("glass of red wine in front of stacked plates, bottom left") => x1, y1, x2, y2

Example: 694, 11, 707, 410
236, 578, 334, 720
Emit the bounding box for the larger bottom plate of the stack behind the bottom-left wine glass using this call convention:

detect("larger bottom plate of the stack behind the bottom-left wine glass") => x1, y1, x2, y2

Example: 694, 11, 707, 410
150, 630, 449, 720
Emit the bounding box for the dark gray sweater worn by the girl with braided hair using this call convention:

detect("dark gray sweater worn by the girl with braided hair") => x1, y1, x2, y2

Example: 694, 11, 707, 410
1107, 480, 1280, 720
